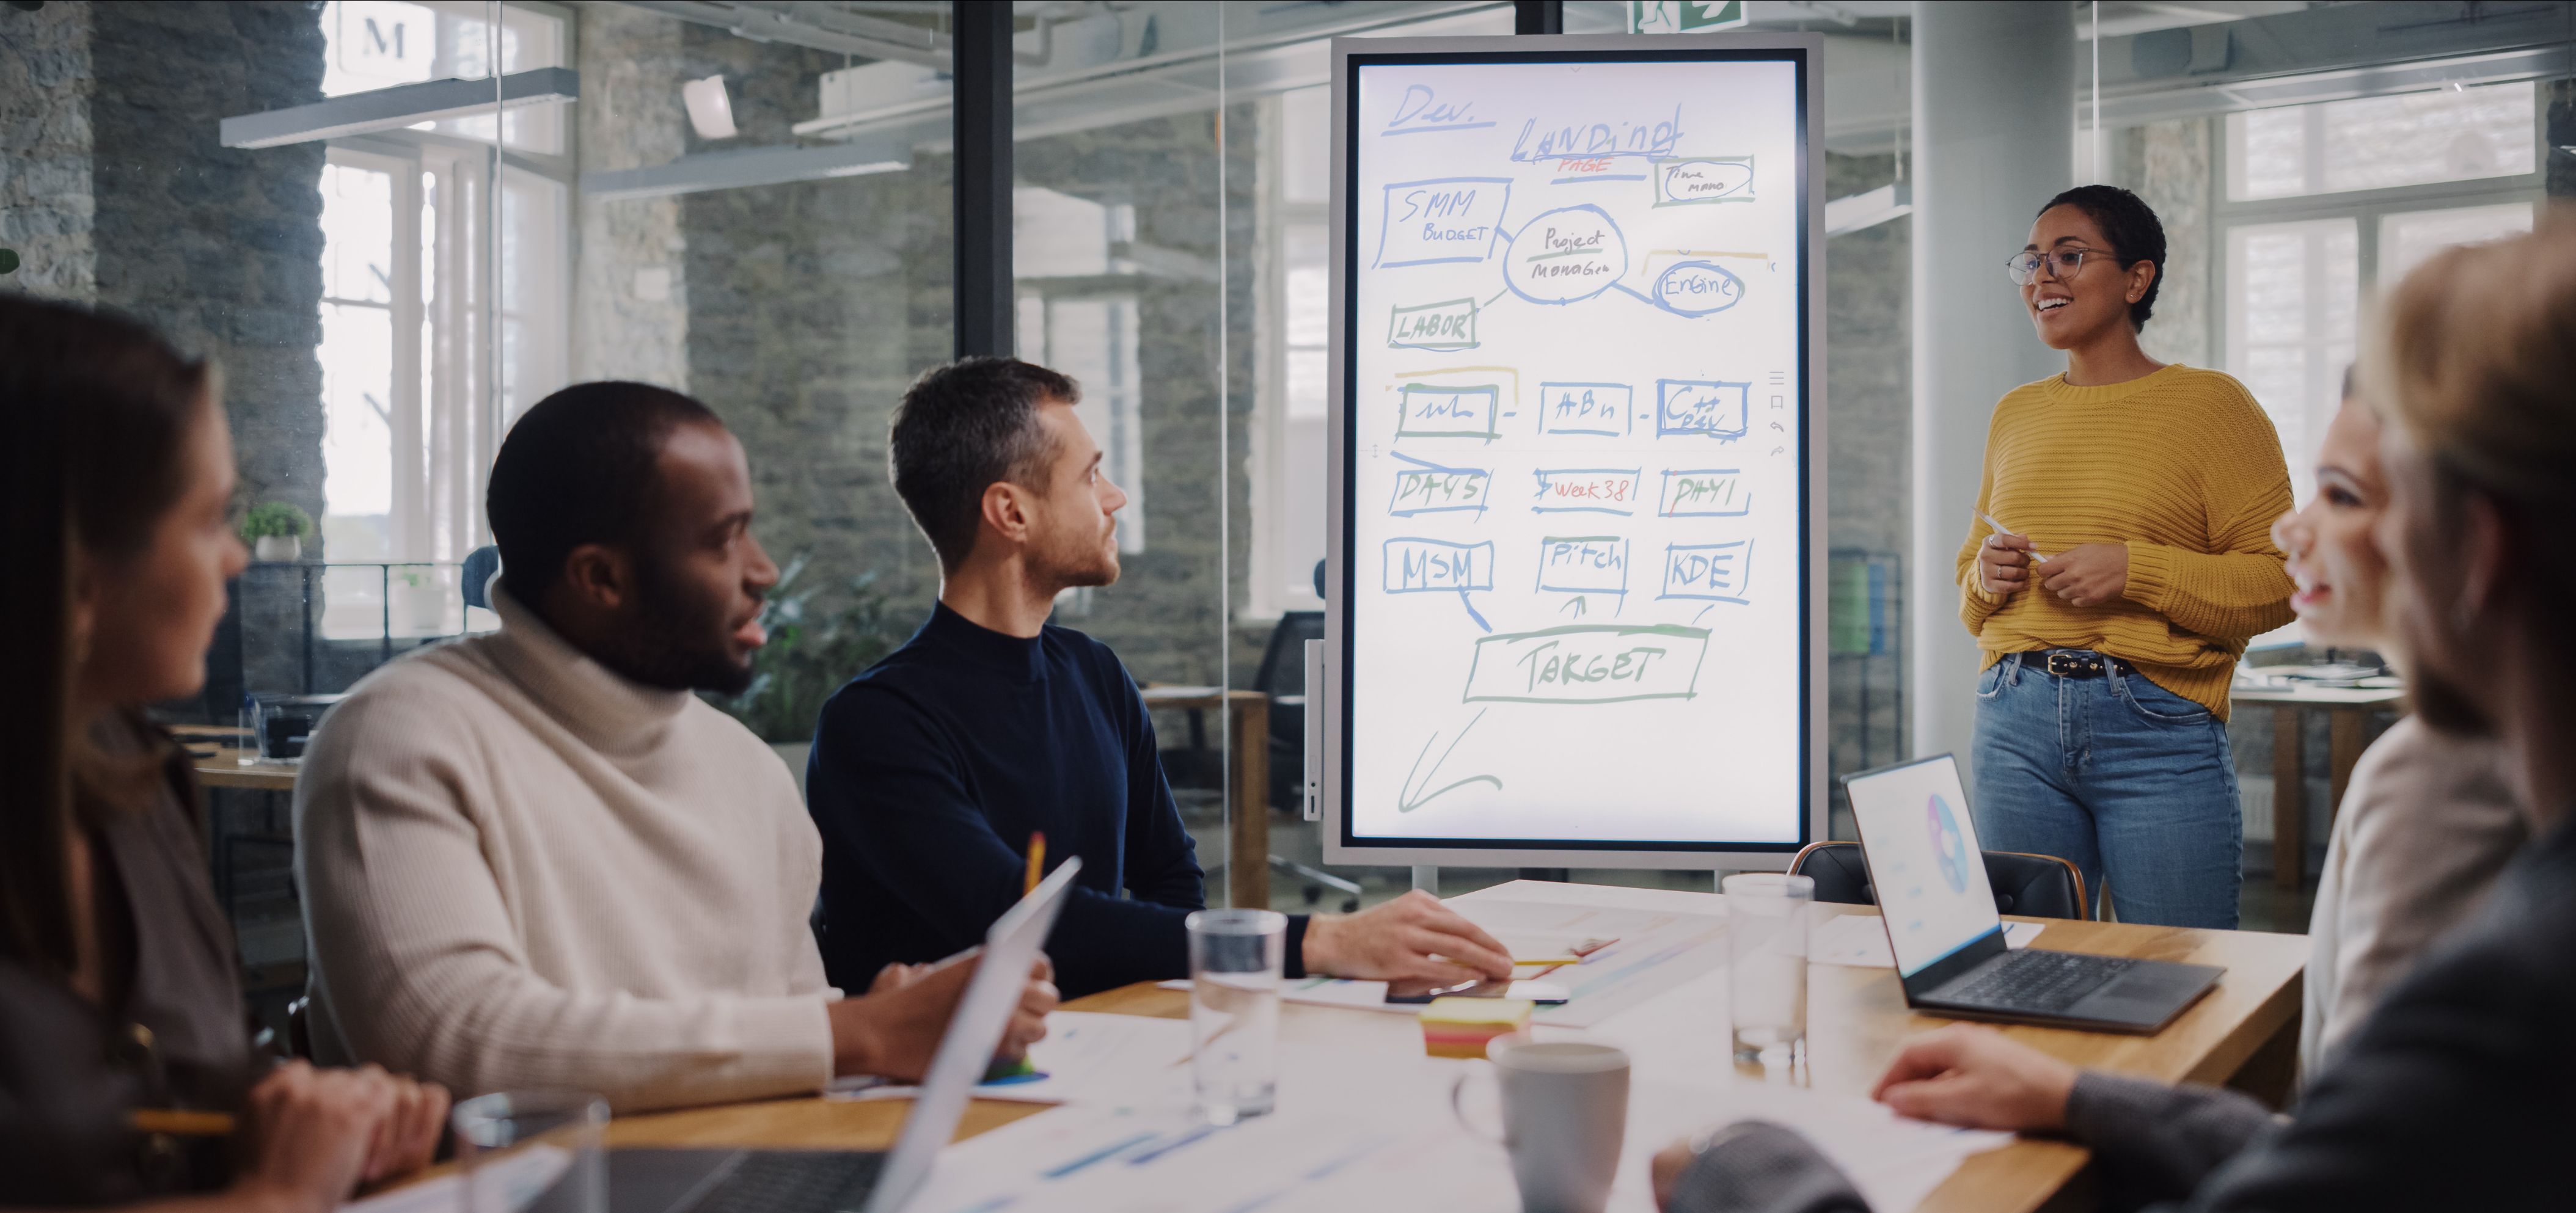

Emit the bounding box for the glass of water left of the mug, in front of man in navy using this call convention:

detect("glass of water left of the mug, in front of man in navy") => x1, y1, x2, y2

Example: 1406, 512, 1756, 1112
1188, 909, 1288, 1126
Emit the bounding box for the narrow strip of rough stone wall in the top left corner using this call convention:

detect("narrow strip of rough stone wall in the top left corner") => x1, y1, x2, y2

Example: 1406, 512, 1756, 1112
0, 2, 98, 301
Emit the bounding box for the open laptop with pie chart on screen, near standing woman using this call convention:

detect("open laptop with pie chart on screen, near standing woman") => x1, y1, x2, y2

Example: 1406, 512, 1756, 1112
1842, 754, 2226, 1033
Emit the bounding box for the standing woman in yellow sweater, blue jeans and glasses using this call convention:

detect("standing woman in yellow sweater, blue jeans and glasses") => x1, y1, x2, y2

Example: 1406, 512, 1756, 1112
1958, 186, 2292, 927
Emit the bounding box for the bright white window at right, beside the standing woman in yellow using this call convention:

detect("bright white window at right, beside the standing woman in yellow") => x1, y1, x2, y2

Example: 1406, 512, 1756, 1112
2220, 82, 2542, 502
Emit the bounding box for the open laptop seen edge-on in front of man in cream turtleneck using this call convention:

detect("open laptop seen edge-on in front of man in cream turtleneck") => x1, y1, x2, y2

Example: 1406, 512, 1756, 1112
574, 858, 1082, 1213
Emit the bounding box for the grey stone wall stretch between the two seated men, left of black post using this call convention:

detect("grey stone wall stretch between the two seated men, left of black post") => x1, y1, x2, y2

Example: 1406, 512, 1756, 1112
670, 26, 956, 636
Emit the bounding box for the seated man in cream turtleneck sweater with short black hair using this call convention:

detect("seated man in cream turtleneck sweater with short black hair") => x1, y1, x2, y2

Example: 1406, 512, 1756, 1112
296, 384, 1056, 1113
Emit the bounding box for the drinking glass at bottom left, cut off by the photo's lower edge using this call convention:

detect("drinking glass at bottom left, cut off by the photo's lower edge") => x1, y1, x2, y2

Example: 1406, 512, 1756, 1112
448, 1092, 608, 1213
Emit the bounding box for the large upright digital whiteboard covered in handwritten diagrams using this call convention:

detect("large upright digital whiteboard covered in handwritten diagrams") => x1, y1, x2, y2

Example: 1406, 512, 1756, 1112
1324, 36, 1824, 868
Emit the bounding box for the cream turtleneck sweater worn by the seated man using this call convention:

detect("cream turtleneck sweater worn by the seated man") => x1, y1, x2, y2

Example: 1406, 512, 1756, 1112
296, 590, 840, 1113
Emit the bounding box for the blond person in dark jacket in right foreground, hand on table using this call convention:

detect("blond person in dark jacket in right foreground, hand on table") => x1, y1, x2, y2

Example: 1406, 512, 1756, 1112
1654, 211, 2576, 1213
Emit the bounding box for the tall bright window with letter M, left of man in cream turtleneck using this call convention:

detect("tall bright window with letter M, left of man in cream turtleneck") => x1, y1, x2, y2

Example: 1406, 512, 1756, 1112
314, 0, 569, 639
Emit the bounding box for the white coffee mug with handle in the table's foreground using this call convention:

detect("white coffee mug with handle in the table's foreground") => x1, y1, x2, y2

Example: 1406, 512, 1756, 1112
1451, 1033, 1628, 1213
